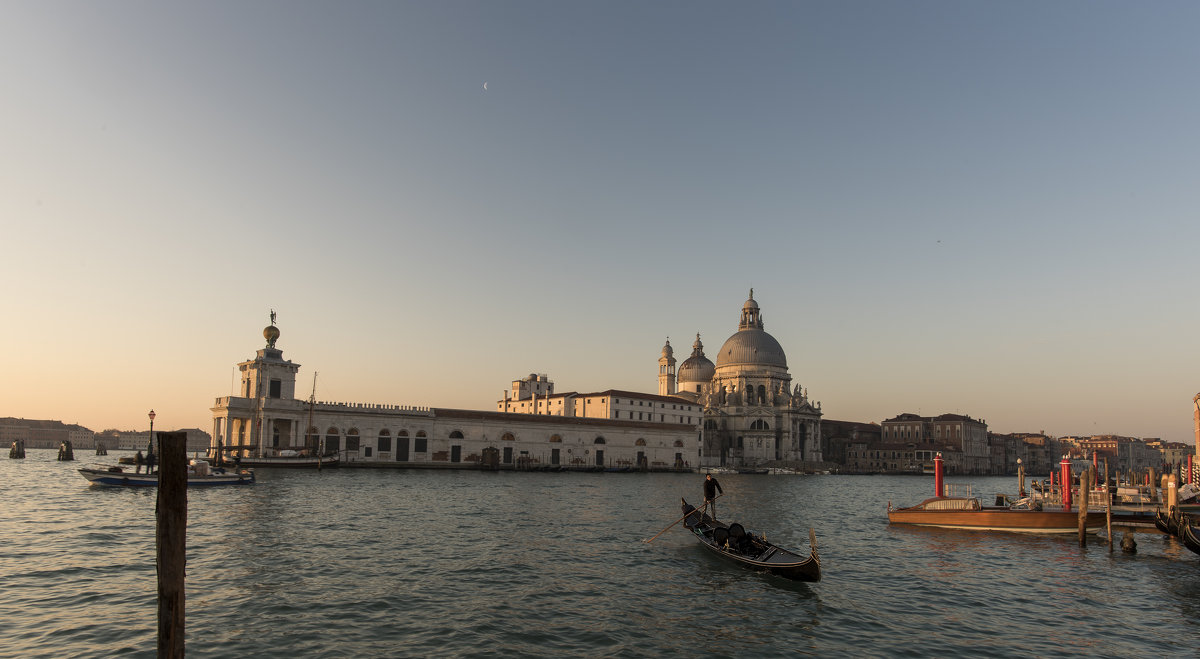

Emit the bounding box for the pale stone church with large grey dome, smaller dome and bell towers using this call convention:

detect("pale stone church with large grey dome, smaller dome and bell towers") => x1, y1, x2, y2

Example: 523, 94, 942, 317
659, 289, 822, 467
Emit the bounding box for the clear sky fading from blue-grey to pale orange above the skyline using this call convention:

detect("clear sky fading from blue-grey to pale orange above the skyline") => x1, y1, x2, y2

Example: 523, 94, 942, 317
0, 0, 1200, 443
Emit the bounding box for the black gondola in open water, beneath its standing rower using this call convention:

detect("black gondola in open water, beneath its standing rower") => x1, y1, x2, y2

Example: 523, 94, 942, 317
680, 499, 821, 581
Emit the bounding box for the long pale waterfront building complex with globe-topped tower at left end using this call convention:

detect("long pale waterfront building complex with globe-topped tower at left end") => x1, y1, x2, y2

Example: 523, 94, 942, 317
211, 318, 698, 469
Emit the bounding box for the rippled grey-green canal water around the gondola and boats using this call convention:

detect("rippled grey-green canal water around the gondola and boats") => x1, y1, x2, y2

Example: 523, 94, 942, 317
0, 450, 1200, 658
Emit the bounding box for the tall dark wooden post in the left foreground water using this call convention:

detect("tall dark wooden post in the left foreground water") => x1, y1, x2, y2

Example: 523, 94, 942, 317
155, 432, 187, 659
